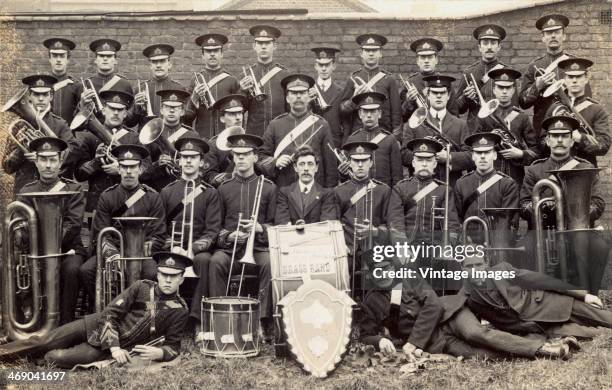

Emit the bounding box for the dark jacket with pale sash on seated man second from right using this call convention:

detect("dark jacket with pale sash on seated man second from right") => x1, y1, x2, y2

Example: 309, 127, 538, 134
455, 170, 519, 221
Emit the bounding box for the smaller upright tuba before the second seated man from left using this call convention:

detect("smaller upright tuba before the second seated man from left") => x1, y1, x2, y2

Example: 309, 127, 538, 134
95, 217, 156, 313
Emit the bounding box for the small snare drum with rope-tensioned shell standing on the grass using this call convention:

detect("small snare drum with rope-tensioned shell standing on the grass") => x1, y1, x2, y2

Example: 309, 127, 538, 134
201, 297, 259, 358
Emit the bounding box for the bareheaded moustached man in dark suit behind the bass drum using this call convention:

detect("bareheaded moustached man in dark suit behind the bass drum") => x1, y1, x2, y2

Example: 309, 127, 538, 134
274, 146, 337, 225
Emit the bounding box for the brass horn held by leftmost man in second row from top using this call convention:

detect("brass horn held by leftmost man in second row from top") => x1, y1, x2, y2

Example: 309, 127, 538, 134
1, 88, 57, 153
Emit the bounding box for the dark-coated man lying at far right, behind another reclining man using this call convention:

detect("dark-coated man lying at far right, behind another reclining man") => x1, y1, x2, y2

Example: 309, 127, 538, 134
462, 251, 612, 337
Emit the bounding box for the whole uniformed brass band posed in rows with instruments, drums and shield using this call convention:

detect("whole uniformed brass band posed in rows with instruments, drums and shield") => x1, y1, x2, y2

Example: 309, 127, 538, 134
0, 14, 612, 377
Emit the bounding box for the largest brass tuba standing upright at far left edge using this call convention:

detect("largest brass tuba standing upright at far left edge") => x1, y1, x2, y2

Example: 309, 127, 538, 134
2, 191, 76, 340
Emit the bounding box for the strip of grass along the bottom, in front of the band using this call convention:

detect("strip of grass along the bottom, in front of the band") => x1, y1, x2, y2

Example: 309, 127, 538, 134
0, 330, 612, 390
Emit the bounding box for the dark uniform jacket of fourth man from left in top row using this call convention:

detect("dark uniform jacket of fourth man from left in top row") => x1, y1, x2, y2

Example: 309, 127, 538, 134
183, 68, 240, 139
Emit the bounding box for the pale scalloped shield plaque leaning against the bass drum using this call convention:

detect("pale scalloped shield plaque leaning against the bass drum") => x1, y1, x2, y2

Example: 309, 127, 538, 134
278, 280, 355, 378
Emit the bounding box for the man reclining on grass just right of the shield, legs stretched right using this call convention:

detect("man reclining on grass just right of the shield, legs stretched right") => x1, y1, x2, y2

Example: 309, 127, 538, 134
359, 253, 578, 359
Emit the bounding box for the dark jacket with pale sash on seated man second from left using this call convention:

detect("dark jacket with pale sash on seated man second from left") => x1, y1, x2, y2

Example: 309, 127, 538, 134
91, 184, 166, 253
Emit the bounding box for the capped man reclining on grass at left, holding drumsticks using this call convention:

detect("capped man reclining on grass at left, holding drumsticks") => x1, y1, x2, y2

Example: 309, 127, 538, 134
0, 252, 191, 368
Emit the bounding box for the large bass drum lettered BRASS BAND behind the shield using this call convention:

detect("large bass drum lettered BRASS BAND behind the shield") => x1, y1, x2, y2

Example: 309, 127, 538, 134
268, 220, 350, 357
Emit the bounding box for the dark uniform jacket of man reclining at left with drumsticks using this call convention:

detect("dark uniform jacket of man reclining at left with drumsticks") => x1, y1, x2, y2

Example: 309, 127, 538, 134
85, 280, 188, 361
